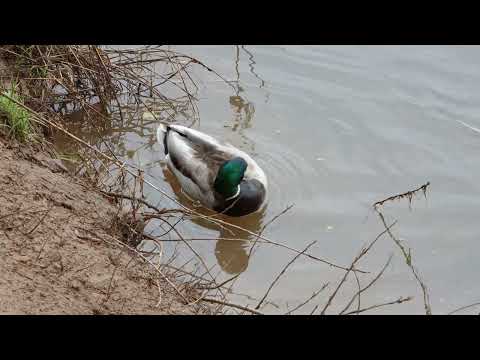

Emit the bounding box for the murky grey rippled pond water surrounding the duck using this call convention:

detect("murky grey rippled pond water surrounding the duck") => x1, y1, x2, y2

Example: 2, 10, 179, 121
61, 46, 480, 314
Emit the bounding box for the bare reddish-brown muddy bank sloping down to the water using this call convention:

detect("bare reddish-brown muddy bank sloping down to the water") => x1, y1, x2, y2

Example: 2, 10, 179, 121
0, 136, 210, 314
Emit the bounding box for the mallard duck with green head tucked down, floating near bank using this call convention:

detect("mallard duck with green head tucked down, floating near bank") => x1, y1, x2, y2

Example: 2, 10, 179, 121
157, 124, 267, 216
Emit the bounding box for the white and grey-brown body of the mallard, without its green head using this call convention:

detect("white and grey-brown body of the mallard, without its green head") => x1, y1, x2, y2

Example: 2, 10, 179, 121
157, 125, 268, 216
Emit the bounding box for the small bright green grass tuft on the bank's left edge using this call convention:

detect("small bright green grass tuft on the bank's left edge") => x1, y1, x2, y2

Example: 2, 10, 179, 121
0, 85, 32, 141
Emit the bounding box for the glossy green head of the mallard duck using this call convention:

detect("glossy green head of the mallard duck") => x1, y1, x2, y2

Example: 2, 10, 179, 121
213, 157, 247, 198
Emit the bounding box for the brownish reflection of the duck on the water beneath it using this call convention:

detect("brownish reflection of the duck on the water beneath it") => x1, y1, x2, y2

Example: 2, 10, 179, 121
164, 170, 265, 275
